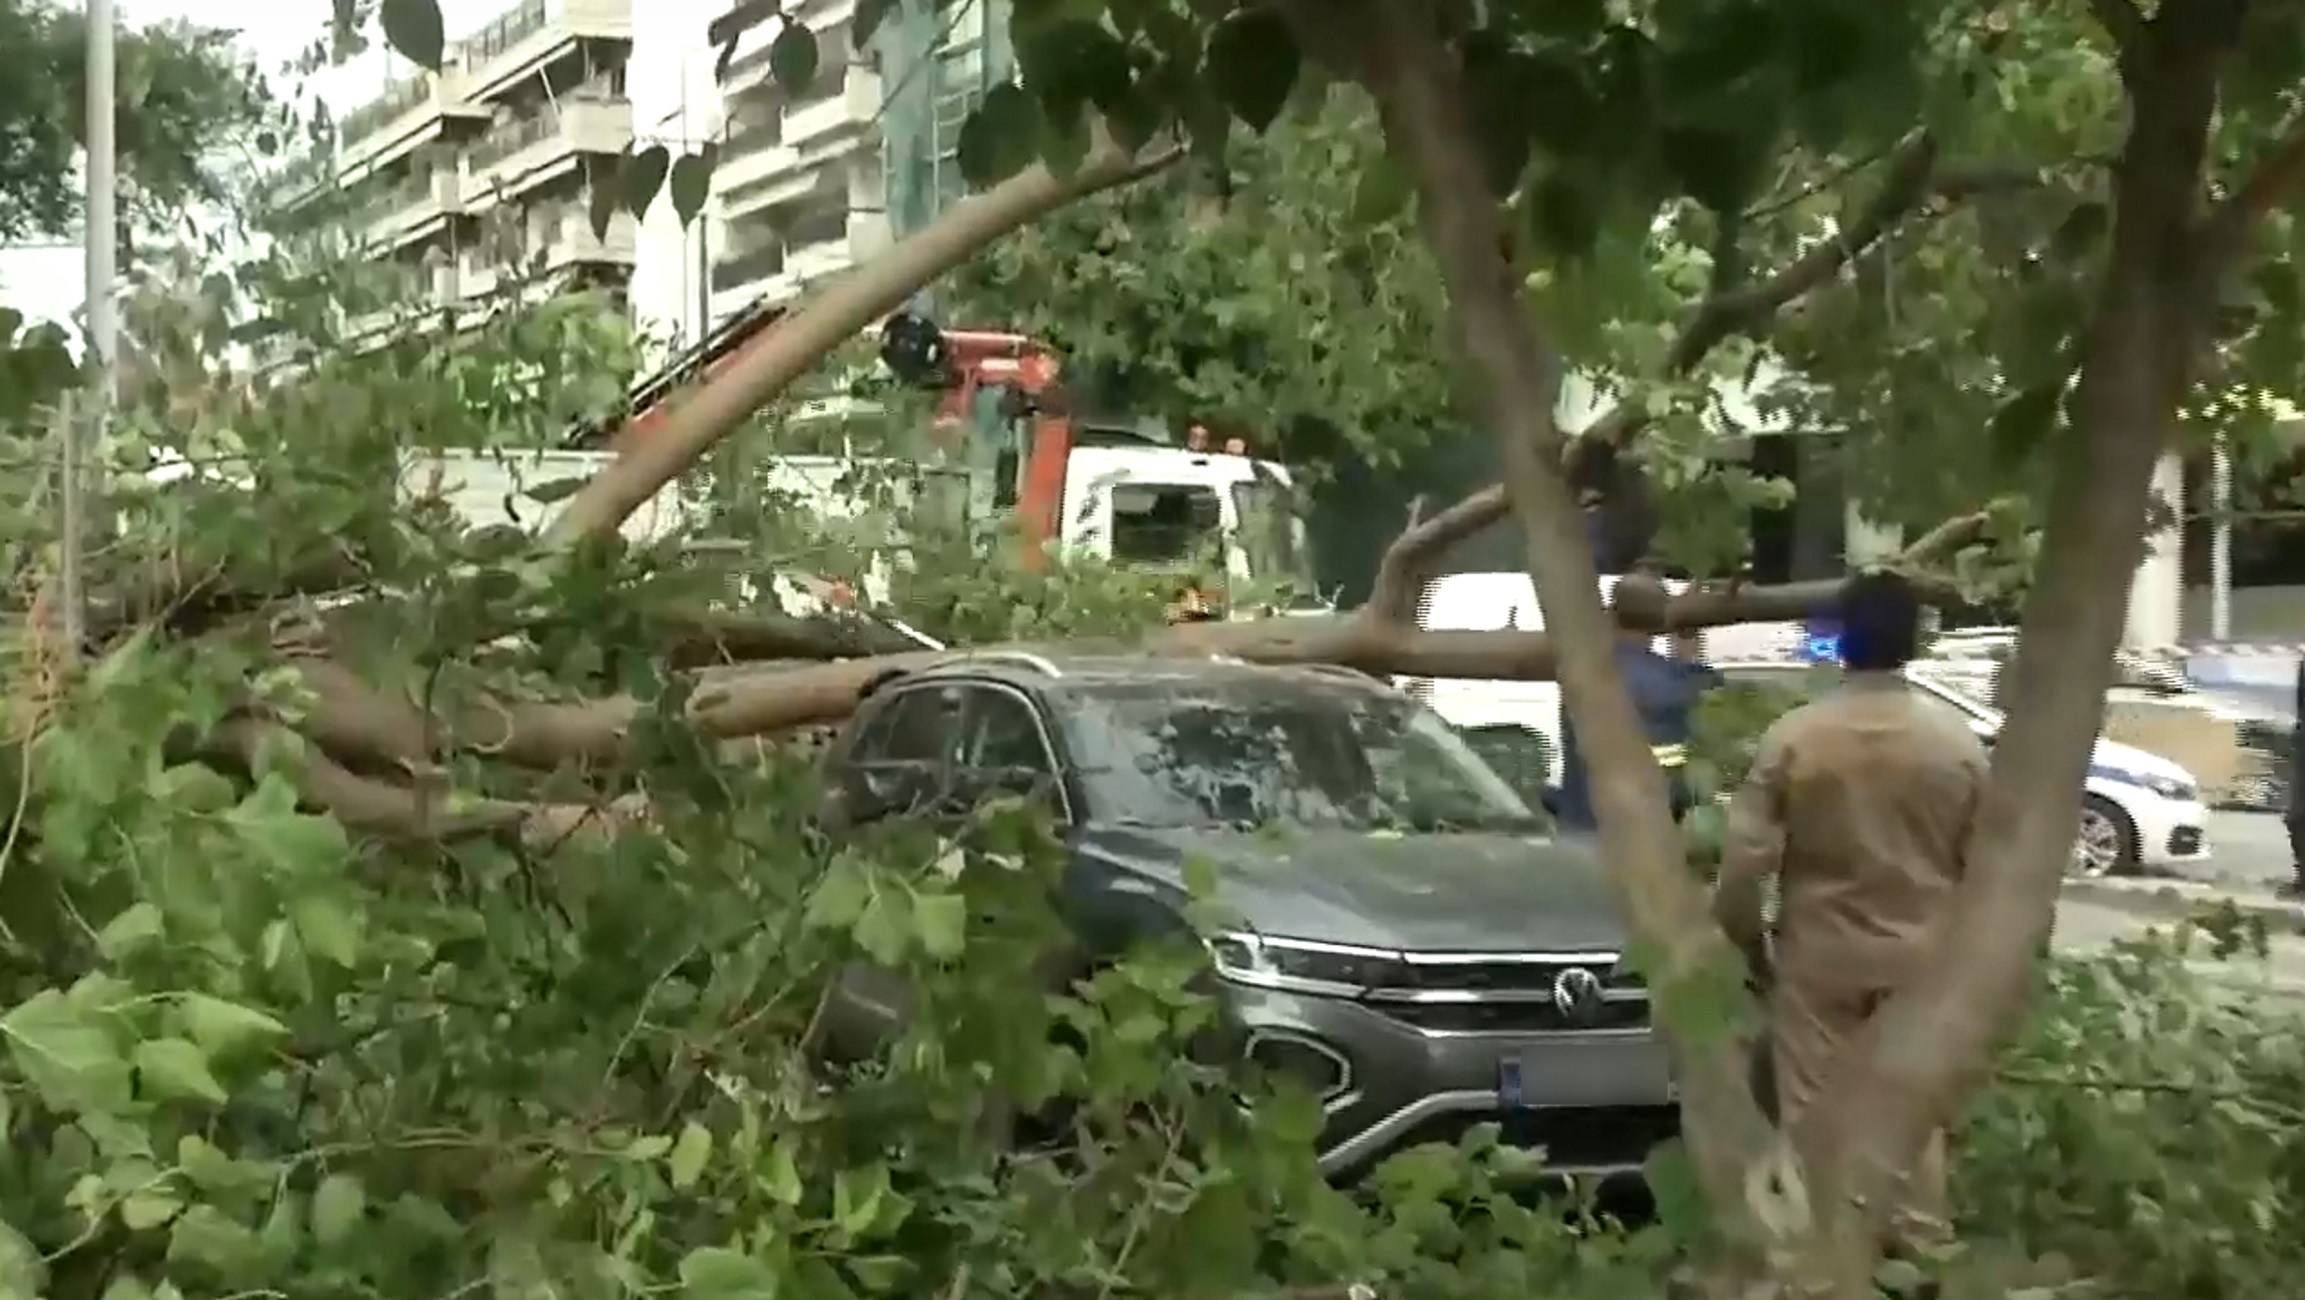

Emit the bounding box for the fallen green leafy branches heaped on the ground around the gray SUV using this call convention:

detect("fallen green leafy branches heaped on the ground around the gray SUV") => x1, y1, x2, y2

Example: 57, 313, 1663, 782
13, 257, 2305, 1300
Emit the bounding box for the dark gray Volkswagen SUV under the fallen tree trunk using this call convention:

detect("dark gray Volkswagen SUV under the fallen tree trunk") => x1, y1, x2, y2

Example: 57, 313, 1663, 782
825, 652, 1678, 1178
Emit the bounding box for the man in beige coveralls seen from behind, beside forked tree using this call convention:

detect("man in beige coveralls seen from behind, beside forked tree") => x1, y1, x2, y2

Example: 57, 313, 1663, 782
1715, 574, 1987, 1254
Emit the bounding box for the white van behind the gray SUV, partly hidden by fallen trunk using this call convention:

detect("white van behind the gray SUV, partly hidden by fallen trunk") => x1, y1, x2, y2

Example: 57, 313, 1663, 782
1397, 572, 1805, 786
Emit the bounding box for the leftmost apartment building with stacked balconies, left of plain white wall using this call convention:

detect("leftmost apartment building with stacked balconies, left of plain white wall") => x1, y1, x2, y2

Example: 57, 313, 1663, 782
300, 0, 638, 329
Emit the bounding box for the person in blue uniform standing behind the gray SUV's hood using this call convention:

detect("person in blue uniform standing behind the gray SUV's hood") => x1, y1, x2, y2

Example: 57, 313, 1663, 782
1554, 574, 1722, 830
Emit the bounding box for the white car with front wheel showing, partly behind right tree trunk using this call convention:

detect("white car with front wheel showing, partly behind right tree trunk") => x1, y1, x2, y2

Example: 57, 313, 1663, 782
1715, 659, 2208, 876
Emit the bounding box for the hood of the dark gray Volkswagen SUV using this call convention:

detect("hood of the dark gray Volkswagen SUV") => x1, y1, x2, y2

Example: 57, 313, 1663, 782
1081, 827, 1625, 952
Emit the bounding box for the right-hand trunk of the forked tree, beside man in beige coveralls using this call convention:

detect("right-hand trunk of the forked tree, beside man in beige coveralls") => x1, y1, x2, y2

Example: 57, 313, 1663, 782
1803, 12, 2222, 1298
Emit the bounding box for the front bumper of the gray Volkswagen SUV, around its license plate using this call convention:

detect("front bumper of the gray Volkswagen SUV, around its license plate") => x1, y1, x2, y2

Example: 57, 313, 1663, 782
1224, 984, 1680, 1180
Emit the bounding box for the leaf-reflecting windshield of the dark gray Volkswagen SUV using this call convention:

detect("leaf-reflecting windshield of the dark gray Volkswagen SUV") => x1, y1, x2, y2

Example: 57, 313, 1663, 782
1065, 675, 1544, 834
